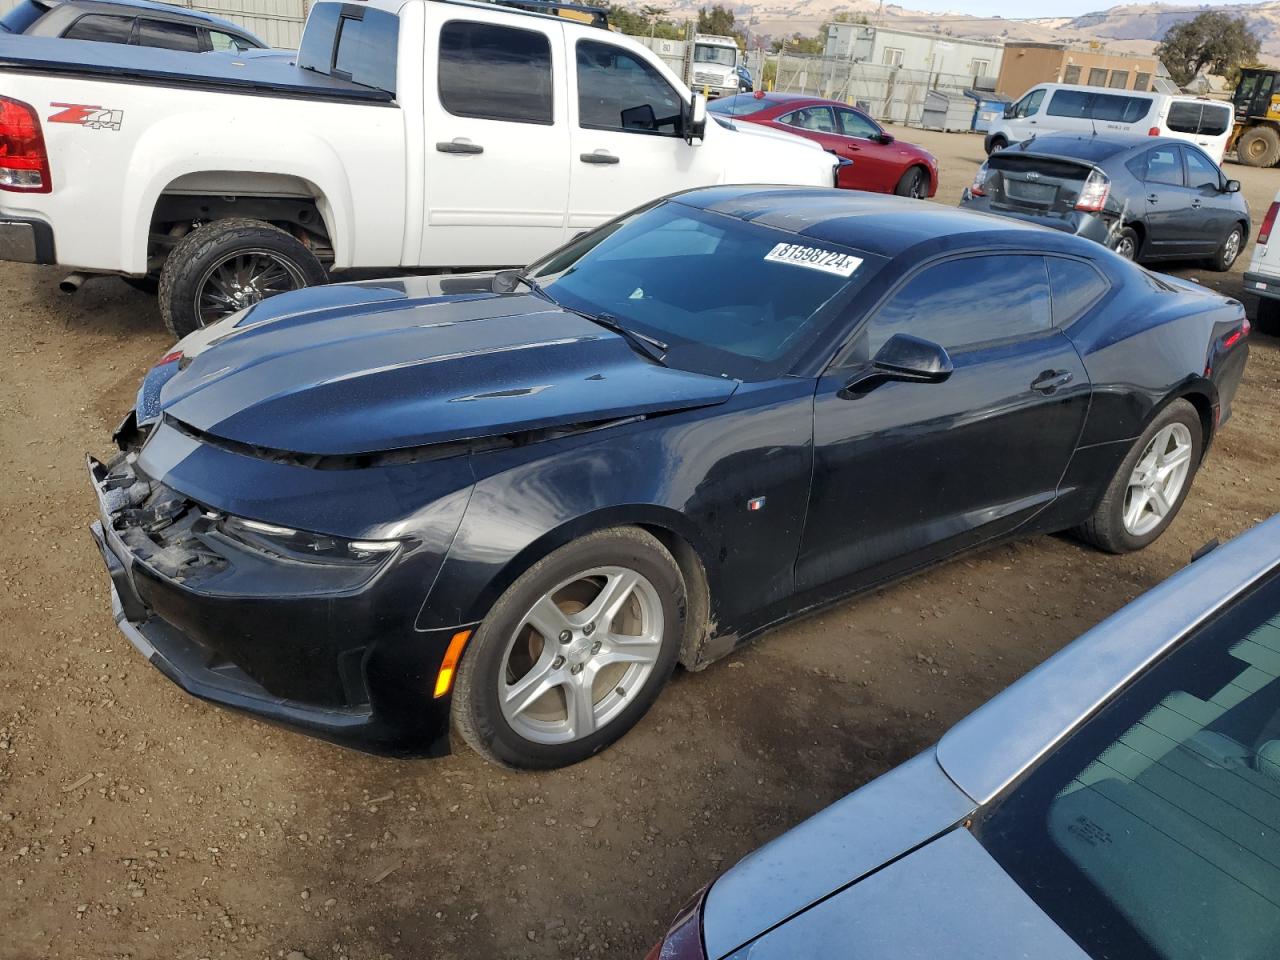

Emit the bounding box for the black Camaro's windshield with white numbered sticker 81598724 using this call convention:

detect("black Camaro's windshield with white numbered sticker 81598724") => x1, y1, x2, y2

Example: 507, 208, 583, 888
529, 201, 873, 380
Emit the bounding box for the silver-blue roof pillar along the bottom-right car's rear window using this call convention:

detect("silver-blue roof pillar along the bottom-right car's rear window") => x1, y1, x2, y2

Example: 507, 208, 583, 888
936, 515, 1280, 804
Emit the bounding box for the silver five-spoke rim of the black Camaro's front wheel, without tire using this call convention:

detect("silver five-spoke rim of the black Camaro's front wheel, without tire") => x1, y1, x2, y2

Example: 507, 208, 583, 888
498, 567, 664, 744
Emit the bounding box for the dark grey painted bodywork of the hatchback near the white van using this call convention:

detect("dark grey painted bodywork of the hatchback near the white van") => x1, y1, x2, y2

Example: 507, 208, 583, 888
960, 134, 1251, 261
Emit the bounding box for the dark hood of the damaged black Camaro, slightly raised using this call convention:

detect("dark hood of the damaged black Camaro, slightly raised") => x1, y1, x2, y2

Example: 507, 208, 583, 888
157, 279, 737, 456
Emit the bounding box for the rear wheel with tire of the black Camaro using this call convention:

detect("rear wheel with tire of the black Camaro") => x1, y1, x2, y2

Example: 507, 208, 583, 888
1076, 399, 1204, 553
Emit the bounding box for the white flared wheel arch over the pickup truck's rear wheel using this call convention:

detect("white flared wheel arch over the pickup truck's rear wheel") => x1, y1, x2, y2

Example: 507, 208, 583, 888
119, 113, 355, 274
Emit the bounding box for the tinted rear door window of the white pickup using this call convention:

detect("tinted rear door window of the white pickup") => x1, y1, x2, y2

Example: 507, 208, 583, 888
438, 20, 554, 124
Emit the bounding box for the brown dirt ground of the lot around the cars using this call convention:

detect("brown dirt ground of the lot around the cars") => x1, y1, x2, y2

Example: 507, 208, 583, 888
0, 131, 1280, 960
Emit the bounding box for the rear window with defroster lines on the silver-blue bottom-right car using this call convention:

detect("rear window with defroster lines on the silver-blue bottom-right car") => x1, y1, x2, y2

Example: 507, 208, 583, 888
974, 572, 1280, 960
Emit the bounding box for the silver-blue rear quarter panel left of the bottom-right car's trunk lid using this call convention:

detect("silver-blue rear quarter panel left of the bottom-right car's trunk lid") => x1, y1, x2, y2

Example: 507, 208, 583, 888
703, 750, 975, 960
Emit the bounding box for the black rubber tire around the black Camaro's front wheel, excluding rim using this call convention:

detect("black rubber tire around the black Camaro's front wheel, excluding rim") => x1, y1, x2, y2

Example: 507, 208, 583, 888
451, 526, 687, 769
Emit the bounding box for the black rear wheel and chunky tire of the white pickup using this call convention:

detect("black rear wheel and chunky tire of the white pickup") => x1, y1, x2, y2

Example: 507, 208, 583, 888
159, 219, 328, 339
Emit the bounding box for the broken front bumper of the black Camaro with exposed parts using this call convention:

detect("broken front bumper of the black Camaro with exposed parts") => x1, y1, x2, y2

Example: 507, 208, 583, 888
87, 454, 471, 755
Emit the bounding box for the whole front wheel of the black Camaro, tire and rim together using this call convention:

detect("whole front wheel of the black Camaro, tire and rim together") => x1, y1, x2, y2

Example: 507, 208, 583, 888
451, 527, 687, 769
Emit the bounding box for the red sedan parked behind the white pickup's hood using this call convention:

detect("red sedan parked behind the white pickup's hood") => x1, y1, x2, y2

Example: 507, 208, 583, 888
707, 91, 938, 200
